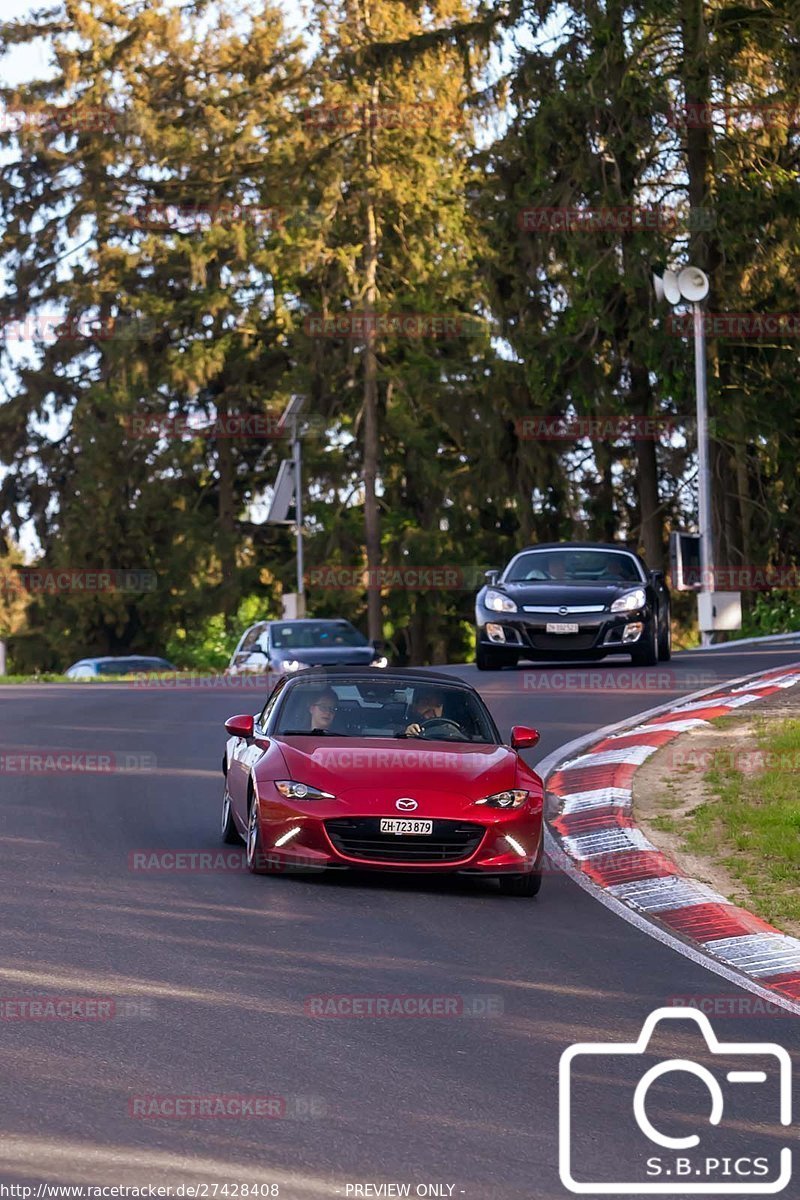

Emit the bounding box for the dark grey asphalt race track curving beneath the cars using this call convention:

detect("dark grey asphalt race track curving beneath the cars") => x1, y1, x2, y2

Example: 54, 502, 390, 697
0, 640, 800, 1200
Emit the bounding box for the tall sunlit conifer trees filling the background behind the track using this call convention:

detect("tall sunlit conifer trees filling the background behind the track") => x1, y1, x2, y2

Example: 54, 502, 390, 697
0, 0, 800, 672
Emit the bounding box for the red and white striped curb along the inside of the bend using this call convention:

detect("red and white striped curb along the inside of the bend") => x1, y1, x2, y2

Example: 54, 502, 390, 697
537, 662, 800, 1015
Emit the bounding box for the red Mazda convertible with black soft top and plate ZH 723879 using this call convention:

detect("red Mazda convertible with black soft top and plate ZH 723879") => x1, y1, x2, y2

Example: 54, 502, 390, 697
222, 667, 543, 896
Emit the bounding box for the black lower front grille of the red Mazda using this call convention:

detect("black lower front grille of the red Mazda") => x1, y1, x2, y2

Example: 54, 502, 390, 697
325, 817, 485, 866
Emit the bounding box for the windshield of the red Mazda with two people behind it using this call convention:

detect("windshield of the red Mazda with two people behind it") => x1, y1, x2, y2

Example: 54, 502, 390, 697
271, 677, 498, 744
